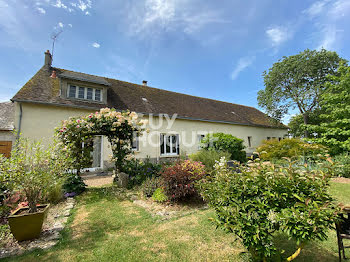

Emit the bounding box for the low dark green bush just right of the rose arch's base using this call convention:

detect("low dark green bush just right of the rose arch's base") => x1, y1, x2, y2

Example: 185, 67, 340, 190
121, 159, 161, 188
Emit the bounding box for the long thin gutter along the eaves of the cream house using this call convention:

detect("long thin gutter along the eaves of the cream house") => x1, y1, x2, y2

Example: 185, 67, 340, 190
11, 99, 288, 129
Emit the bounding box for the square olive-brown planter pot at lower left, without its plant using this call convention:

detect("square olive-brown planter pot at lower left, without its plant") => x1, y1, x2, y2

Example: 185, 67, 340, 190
8, 204, 50, 241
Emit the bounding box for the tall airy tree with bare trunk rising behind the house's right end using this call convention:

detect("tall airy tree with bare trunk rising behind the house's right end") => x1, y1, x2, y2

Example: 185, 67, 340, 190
258, 49, 345, 137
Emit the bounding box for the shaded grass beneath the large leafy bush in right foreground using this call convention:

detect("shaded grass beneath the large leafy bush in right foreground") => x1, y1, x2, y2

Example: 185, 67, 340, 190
273, 234, 338, 262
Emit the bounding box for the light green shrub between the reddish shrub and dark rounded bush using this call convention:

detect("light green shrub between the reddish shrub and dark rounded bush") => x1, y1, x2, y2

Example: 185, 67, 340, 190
189, 149, 231, 172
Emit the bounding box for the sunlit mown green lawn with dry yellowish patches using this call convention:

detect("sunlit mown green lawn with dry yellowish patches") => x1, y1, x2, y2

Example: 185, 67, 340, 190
5, 183, 350, 262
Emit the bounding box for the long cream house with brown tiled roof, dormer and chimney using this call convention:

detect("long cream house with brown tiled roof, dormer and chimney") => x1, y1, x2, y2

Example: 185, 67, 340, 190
12, 51, 287, 168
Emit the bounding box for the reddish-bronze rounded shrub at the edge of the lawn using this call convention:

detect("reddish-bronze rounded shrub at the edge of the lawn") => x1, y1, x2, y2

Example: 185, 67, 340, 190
161, 160, 205, 201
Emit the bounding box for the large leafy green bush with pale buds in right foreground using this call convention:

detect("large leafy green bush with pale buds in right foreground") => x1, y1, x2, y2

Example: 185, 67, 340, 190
199, 159, 339, 261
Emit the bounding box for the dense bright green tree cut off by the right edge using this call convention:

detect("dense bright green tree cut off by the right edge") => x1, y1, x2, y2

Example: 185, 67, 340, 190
308, 65, 350, 154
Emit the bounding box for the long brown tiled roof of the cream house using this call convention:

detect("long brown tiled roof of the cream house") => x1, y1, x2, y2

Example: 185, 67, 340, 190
12, 67, 286, 128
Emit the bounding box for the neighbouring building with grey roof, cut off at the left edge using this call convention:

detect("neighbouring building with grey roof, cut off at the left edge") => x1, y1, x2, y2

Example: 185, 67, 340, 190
0, 102, 15, 157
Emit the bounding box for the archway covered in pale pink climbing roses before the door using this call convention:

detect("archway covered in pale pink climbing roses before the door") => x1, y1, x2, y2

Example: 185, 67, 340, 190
56, 108, 146, 173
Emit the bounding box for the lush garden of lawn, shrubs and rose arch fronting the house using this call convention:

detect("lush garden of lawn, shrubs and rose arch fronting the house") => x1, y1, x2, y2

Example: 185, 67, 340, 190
0, 51, 350, 261
